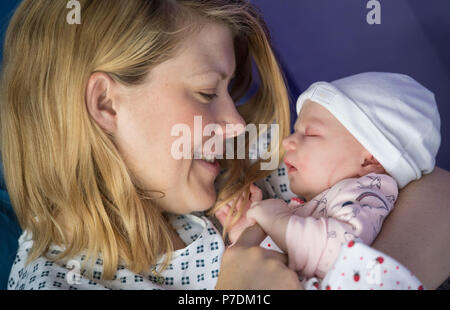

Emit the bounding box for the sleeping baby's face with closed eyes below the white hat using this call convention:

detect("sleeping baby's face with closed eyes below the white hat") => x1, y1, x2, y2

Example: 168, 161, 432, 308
283, 100, 367, 200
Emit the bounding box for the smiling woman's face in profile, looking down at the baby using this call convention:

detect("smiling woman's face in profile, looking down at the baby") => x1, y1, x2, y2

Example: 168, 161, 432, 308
113, 23, 245, 214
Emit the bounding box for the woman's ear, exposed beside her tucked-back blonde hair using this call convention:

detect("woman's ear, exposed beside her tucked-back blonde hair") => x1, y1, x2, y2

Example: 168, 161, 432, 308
86, 72, 117, 133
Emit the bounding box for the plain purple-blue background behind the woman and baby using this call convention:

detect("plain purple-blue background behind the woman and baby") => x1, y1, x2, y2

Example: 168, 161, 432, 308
0, 0, 450, 289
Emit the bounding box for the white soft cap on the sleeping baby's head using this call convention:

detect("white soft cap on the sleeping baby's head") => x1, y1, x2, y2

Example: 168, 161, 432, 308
297, 72, 441, 188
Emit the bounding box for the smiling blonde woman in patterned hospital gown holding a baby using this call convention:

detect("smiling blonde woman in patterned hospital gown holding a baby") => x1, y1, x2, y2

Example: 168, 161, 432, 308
0, 0, 448, 289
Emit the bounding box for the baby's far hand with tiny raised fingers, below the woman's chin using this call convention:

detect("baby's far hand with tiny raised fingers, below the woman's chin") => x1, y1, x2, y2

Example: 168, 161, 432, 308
215, 184, 262, 243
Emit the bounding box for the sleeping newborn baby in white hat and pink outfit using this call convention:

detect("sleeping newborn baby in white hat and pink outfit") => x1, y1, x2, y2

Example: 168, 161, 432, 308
216, 72, 440, 278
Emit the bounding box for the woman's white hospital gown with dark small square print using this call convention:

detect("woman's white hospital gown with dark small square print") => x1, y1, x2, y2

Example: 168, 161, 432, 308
8, 215, 224, 290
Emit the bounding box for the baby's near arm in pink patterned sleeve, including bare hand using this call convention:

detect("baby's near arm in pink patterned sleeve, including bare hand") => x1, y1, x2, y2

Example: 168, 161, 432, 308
247, 175, 397, 277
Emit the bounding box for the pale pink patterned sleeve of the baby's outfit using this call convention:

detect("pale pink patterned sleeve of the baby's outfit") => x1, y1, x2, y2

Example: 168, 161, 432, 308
286, 173, 398, 278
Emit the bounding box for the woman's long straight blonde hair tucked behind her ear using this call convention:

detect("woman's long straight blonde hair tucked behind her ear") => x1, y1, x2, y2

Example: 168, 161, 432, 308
0, 0, 290, 279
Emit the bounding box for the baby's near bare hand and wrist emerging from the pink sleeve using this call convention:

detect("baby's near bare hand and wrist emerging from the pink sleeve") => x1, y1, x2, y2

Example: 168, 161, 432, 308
247, 199, 293, 253
